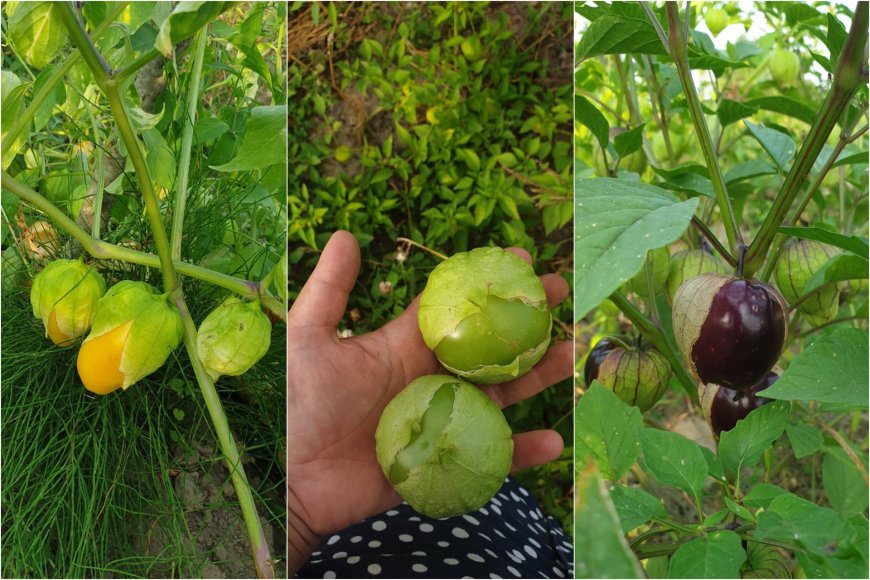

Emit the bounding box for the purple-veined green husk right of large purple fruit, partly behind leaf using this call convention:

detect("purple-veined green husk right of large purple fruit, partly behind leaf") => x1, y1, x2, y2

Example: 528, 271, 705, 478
775, 239, 840, 326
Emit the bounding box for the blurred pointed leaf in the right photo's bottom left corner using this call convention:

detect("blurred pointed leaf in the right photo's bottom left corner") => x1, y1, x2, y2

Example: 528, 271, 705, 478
574, 462, 644, 578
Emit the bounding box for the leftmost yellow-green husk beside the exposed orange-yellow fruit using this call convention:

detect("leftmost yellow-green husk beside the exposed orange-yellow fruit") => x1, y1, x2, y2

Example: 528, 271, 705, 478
30, 260, 106, 346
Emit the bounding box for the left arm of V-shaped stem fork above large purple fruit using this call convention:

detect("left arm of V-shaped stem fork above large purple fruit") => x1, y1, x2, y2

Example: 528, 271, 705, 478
665, 2, 743, 254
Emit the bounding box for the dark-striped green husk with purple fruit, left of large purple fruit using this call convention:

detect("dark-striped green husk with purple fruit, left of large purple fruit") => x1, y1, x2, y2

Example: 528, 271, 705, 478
583, 338, 671, 413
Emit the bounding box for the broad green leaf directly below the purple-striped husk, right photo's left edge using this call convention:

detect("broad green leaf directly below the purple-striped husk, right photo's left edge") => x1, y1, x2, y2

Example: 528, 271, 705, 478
574, 382, 642, 481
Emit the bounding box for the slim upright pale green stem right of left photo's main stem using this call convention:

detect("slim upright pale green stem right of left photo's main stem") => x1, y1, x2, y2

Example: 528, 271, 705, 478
172, 28, 208, 260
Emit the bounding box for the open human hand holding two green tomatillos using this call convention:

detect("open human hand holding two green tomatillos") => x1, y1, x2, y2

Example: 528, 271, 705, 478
287, 231, 573, 572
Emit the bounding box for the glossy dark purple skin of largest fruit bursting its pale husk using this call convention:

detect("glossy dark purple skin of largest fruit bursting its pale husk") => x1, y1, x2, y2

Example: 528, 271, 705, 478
692, 278, 786, 391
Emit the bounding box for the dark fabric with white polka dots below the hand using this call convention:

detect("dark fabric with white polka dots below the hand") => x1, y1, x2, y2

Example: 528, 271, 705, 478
298, 477, 574, 578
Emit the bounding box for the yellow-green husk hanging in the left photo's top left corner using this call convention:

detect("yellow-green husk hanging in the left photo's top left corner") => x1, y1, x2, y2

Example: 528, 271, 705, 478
9, 2, 67, 68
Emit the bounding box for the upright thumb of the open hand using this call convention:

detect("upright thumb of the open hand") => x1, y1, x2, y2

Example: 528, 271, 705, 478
287, 231, 360, 330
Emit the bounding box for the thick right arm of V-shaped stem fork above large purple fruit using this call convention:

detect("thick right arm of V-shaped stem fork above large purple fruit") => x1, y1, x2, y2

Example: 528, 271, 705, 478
745, 2, 868, 275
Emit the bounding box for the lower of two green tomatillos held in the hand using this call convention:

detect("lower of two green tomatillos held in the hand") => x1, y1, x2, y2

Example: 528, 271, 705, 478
375, 375, 514, 518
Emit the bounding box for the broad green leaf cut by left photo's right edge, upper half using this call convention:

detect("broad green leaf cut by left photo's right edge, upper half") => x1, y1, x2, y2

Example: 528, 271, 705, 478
212, 105, 287, 171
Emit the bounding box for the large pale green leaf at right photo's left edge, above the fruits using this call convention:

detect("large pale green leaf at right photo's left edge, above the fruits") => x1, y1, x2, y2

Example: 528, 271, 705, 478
574, 178, 698, 320
